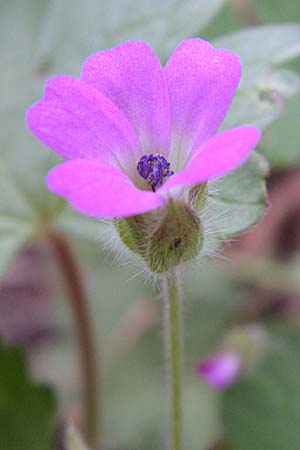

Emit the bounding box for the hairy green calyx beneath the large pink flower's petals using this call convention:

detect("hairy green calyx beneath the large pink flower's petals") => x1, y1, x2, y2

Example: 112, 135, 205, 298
116, 201, 203, 273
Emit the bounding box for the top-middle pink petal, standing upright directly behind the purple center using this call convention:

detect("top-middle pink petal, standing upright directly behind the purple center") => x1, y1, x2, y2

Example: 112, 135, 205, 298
82, 41, 170, 154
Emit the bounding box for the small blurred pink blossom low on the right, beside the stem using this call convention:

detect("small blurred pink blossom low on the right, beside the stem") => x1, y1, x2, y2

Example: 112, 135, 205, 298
197, 351, 241, 389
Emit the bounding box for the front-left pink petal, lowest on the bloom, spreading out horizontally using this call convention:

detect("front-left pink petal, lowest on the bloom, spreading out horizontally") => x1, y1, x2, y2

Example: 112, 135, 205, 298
46, 159, 164, 218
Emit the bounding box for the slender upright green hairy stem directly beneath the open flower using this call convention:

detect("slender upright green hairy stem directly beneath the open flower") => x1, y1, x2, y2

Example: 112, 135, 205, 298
164, 271, 183, 450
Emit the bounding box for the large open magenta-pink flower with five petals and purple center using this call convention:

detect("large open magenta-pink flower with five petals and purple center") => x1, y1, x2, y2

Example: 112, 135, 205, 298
27, 39, 260, 218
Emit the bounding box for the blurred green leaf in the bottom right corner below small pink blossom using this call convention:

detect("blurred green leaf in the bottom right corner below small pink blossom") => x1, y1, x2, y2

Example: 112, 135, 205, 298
222, 333, 300, 450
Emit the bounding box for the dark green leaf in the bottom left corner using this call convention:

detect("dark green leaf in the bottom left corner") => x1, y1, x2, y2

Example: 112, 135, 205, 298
0, 344, 56, 450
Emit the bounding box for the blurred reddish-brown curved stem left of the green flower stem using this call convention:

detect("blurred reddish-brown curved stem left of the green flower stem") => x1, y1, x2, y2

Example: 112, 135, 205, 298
47, 230, 99, 449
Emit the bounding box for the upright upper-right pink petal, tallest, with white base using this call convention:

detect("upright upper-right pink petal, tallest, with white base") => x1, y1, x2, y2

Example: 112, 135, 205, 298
165, 38, 241, 169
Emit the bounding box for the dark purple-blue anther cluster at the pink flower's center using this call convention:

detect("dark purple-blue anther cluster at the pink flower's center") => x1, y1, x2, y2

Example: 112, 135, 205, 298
136, 153, 174, 192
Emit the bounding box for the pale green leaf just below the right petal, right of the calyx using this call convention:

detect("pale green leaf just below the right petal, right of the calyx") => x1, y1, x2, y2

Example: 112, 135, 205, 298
209, 152, 268, 239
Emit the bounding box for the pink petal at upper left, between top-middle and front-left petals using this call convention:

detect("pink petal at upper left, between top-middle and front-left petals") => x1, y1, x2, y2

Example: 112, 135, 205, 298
27, 75, 141, 173
